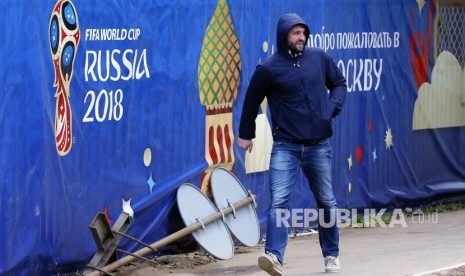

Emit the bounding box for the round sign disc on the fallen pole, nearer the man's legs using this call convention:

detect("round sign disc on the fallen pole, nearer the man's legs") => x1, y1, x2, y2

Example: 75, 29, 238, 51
210, 167, 260, 246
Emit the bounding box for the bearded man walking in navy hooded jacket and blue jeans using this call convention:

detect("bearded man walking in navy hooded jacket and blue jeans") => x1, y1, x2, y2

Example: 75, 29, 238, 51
237, 14, 347, 275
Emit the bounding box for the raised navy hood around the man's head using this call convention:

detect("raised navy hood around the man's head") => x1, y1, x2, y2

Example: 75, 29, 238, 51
276, 13, 310, 55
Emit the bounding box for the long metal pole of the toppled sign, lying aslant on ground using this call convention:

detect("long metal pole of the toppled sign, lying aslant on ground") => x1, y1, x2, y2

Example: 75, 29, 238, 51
86, 195, 254, 276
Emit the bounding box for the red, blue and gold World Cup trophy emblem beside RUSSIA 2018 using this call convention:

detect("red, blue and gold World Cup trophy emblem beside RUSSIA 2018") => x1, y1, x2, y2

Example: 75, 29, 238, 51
49, 0, 80, 156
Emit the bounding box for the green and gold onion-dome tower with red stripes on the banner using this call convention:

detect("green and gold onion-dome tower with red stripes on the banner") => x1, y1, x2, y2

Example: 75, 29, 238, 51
198, 0, 241, 194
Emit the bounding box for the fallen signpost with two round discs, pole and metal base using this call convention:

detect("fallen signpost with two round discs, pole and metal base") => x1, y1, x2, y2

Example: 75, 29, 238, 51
86, 170, 260, 276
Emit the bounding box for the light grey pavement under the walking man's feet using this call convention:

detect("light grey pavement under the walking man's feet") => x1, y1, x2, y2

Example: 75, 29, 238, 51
166, 210, 465, 276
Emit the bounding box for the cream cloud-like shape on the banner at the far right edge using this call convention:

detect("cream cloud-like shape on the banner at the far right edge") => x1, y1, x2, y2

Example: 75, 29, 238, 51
413, 51, 465, 130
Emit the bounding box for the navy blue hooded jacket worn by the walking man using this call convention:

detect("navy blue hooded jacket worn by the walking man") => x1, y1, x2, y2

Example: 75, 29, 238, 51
239, 14, 347, 144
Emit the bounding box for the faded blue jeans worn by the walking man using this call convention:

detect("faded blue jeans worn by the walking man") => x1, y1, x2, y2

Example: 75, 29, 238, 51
265, 139, 339, 263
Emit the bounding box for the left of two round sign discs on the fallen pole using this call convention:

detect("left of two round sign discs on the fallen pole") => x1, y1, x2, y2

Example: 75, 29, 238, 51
177, 183, 234, 260
